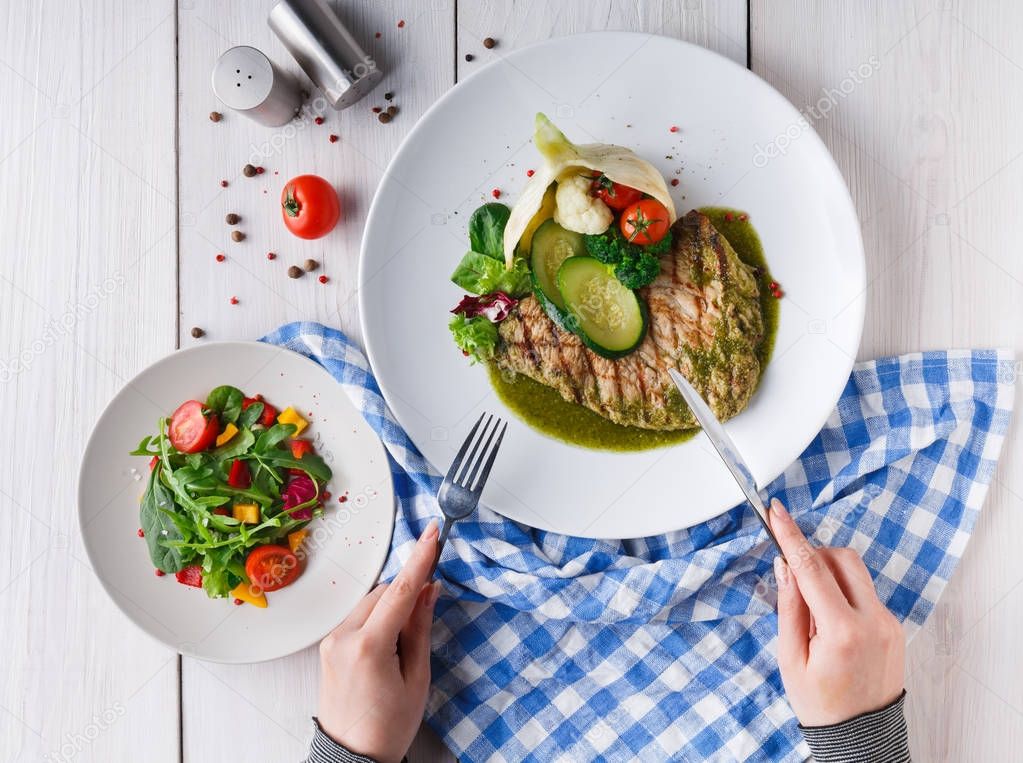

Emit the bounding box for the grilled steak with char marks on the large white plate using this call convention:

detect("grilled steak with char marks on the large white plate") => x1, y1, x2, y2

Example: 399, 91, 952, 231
495, 211, 764, 430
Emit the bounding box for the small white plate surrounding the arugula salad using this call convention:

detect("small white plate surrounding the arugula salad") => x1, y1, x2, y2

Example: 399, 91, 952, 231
78, 342, 394, 663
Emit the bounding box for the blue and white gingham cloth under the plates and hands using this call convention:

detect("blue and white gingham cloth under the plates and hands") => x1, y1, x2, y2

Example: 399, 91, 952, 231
265, 323, 1016, 761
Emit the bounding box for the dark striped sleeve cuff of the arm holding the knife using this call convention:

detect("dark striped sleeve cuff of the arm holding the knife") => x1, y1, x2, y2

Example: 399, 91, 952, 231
799, 691, 910, 763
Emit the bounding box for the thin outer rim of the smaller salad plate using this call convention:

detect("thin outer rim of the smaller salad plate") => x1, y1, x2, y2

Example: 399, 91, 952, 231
75, 340, 398, 665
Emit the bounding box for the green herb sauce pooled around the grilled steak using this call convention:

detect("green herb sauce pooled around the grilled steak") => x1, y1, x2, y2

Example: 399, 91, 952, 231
488, 207, 779, 451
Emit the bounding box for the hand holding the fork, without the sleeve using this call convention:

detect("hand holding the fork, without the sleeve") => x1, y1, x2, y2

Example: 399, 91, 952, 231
318, 513, 440, 763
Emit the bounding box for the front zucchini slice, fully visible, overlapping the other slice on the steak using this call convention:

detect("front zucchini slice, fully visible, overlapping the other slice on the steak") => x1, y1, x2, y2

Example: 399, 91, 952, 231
558, 257, 647, 359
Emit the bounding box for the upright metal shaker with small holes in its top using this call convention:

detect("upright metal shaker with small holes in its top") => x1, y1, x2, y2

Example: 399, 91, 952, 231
213, 45, 301, 127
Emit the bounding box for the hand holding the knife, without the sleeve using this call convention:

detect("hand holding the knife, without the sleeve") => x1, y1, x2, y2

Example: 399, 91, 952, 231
770, 499, 905, 726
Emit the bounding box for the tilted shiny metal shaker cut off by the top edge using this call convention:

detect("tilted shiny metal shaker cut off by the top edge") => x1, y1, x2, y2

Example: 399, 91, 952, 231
267, 0, 384, 109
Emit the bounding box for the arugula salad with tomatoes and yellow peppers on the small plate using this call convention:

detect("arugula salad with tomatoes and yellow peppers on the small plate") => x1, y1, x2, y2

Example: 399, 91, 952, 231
131, 386, 331, 608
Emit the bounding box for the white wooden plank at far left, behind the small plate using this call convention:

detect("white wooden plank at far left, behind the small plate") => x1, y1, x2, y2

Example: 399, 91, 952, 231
0, 0, 178, 763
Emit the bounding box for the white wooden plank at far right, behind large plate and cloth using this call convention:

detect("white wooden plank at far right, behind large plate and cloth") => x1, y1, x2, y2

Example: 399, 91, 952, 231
751, 0, 1023, 761
